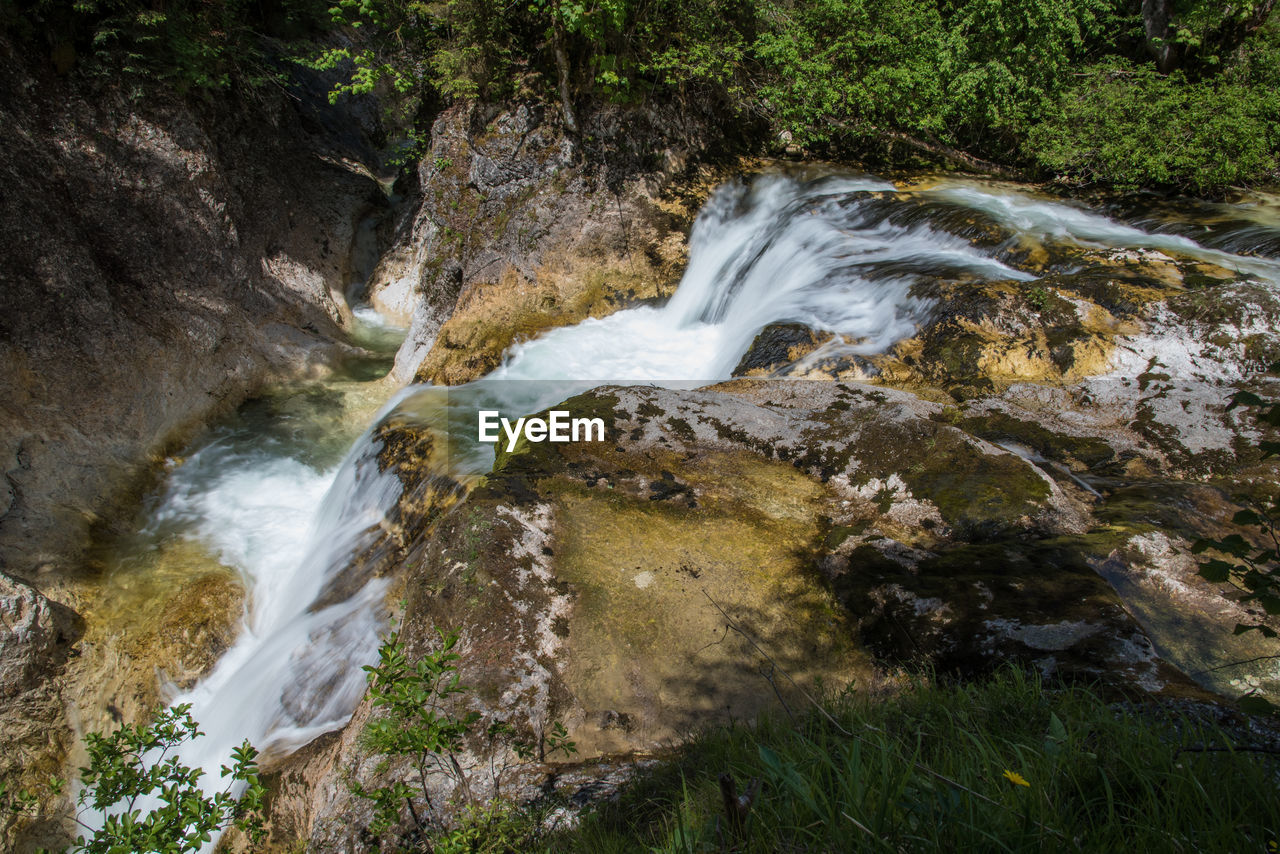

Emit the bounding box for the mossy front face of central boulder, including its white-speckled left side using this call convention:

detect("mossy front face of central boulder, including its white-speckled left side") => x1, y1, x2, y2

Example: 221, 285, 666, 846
406, 435, 869, 755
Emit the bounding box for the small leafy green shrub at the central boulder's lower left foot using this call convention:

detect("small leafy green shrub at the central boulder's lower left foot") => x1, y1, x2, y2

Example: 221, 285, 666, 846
352, 631, 577, 850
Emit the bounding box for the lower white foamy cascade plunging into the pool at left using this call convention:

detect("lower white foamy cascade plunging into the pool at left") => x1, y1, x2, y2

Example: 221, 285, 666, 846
156, 405, 399, 752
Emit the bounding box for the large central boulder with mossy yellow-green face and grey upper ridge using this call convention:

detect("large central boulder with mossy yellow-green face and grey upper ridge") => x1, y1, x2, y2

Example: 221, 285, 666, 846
386, 380, 1090, 753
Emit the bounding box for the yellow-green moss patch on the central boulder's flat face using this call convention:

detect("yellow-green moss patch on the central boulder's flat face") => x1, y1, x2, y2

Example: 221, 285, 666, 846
544, 453, 867, 749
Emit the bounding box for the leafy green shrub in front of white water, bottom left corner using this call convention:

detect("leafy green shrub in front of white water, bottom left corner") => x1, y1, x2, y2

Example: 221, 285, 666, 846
76, 705, 265, 854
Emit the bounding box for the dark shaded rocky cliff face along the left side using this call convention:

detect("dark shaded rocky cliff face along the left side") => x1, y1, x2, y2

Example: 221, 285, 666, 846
0, 40, 385, 588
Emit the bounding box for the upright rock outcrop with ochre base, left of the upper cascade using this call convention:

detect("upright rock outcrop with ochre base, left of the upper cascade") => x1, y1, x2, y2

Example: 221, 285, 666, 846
370, 98, 737, 385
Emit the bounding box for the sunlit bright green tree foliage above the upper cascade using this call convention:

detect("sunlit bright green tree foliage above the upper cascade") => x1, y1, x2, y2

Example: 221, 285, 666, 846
293, 0, 1280, 192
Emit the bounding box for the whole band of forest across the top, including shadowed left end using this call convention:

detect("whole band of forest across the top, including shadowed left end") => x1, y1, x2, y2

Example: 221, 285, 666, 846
0, 0, 1280, 193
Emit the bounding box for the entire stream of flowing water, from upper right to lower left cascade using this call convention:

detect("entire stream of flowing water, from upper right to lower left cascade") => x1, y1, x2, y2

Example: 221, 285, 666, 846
90, 173, 1280, 839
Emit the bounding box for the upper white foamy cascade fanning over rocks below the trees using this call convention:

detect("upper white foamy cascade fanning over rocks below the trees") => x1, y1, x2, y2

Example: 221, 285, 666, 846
490, 175, 1033, 386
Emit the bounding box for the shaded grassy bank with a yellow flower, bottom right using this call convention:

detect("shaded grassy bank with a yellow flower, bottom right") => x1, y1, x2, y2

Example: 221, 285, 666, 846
552, 668, 1280, 853
